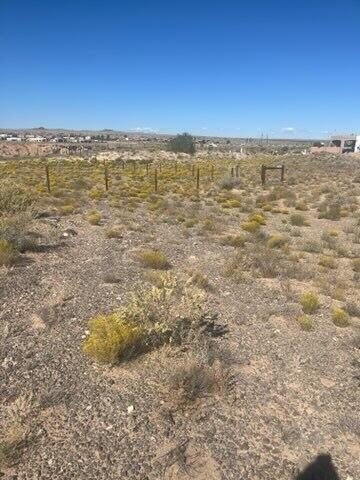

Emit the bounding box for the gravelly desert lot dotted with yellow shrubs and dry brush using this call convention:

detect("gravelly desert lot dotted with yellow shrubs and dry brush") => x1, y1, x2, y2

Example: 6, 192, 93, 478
0, 152, 360, 480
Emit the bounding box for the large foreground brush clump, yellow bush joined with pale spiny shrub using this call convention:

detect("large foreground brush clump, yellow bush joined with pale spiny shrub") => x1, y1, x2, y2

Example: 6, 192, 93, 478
83, 272, 210, 364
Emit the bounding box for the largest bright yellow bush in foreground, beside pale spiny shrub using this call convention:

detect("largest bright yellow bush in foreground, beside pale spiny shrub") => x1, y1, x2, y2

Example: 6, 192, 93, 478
83, 312, 143, 363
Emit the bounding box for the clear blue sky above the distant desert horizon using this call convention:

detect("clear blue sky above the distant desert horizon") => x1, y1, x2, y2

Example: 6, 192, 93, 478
0, 0, 360, 138
